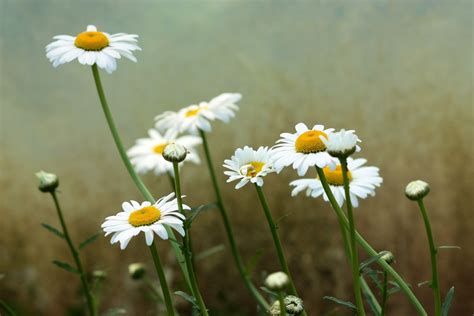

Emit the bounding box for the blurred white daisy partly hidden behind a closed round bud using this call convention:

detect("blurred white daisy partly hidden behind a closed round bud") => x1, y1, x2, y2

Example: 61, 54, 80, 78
127, 129, 202, 175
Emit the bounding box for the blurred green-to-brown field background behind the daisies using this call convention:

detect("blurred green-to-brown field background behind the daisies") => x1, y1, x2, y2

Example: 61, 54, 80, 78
0, 0, 474, 315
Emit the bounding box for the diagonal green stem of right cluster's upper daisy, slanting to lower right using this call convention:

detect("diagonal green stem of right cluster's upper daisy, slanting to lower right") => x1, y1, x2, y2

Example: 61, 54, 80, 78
316, 167, 428, 316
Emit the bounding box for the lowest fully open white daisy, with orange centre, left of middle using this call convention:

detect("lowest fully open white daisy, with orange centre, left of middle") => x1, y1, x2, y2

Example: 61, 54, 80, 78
101, 193, 190, 250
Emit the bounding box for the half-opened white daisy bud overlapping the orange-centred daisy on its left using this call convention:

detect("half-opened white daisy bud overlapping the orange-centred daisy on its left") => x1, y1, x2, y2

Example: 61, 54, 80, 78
319, 129, 361, 158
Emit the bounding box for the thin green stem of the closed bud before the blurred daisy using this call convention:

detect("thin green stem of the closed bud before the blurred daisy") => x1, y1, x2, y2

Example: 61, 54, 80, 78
173, 162, 208, 316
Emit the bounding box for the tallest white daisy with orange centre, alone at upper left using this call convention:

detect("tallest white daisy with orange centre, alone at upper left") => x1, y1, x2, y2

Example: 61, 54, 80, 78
46, 25, 141, 73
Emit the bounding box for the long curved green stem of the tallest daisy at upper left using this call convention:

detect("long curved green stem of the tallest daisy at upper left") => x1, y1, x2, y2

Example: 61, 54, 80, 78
92, 64, 191, 289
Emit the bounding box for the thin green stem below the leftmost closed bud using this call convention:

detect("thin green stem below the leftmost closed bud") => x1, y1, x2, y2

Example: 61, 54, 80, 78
51, 191, 97, 316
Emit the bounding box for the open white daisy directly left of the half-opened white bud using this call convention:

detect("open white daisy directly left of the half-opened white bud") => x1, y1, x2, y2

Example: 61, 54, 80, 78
273, 123, 336, 176
